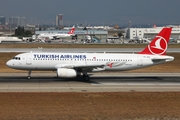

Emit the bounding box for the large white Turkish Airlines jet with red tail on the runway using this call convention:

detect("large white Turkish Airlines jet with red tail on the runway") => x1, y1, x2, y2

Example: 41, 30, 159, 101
6, 28, 174, 81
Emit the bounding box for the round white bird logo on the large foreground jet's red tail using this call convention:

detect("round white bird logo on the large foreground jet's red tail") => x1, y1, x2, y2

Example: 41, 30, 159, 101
148, 36, 167, 55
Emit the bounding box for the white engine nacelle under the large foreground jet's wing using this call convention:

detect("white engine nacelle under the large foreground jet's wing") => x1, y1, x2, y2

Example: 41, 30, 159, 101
57, 68, 77, 78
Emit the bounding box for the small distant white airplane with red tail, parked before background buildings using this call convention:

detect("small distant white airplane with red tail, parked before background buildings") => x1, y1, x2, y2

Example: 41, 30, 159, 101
37, 26, 75, 40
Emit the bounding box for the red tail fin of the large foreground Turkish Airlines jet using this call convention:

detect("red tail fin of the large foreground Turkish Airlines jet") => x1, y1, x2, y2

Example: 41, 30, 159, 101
139, 28, 172, 55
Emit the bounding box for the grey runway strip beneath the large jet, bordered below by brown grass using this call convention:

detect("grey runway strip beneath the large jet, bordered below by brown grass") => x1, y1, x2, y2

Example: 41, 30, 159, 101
0, 73, 180, 92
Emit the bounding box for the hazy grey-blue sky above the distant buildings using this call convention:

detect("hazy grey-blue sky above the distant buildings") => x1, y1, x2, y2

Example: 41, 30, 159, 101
0, 0, 180, 25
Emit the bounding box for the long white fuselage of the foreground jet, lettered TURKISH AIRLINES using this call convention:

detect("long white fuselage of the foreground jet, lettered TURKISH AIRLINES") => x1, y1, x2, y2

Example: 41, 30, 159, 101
6, 53, 174, 72
